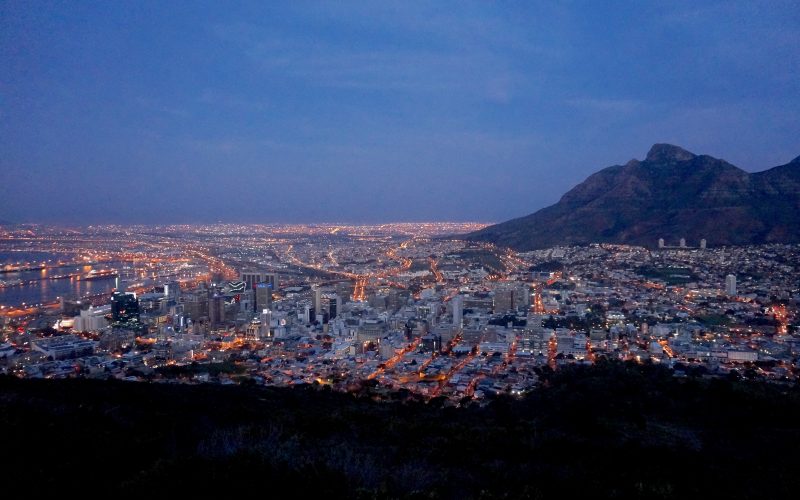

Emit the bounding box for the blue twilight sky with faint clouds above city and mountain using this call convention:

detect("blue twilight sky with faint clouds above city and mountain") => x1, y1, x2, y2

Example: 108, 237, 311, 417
0, 0, 800, 224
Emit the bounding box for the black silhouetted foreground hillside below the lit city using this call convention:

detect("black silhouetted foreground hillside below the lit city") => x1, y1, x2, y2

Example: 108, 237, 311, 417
0, 363, 800, 499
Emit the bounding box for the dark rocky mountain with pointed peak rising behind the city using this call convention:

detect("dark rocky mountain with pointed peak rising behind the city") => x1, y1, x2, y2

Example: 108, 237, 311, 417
465, 144, 800, 250
